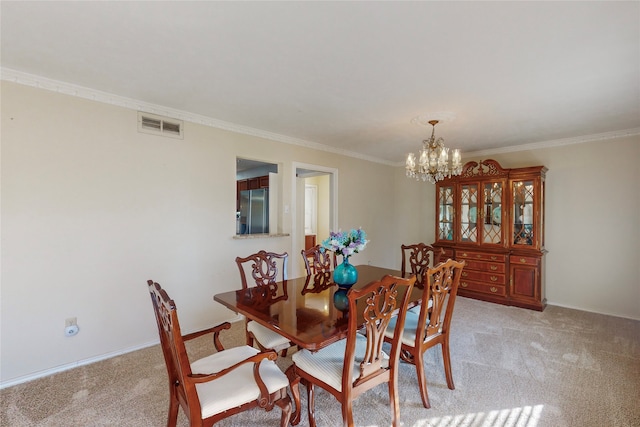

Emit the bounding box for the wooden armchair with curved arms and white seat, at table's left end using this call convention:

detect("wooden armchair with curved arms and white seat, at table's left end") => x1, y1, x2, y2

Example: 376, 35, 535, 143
147, 280, 292, 427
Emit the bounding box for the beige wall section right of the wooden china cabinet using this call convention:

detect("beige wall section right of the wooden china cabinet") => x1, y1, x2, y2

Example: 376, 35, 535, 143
464, 140, 640, 319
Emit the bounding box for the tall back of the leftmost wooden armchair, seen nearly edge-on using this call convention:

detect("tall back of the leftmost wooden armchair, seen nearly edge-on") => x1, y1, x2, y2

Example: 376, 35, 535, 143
147, 280, 201, 420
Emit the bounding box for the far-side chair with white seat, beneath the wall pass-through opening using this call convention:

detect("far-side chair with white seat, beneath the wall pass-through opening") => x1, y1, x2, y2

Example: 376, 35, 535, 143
236, 250, 293, 356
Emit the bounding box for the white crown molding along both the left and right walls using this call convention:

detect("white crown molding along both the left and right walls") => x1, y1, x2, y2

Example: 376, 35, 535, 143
0, 67, 640, 167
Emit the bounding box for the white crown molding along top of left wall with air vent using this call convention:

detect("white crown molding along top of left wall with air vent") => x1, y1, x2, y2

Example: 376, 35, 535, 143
0, 67, 395, 166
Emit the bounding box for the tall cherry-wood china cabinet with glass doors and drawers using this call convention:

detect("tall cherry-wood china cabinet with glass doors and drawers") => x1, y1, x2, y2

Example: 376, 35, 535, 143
433, 159, 547, 311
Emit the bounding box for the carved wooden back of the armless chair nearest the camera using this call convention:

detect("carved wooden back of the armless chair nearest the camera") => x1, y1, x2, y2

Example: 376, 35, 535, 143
342, 275, 416, 392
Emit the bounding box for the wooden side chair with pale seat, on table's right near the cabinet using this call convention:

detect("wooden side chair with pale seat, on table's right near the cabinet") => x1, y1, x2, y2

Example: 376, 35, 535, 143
385, 259, 465, 408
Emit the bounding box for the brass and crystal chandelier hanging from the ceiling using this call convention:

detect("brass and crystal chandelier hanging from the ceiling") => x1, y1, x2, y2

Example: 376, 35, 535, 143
406, 120, 462, 184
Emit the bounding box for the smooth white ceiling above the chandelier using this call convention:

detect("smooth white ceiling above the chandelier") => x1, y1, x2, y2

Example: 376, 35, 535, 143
0, 1, 640, 164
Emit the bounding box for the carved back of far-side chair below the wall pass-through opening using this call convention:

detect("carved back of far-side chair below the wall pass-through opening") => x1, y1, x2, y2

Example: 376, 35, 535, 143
236, 250, 289, 289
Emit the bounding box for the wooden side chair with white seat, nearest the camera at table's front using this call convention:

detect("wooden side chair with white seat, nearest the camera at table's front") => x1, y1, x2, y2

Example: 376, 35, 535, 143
287, 275, 415, 427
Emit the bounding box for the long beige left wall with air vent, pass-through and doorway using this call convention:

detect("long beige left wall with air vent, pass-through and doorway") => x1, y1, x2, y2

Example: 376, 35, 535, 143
0, 81, 430, 384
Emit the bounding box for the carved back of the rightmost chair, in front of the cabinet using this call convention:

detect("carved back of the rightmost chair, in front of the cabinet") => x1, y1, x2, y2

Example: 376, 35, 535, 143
416, 259, 465, 346
